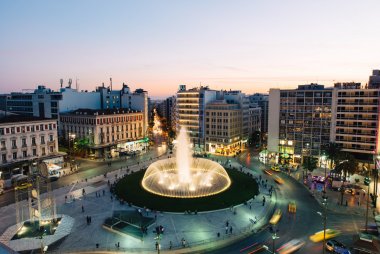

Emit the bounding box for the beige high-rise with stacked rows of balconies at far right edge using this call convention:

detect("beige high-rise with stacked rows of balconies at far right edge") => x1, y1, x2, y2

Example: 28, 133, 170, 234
331, 82, 380, 161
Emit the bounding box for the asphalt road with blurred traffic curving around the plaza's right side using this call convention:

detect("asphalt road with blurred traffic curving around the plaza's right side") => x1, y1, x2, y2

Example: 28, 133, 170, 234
206, 151, 364, 254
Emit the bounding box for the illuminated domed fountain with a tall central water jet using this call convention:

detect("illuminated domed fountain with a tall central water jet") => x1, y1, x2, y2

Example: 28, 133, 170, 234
141, 128, 231, 198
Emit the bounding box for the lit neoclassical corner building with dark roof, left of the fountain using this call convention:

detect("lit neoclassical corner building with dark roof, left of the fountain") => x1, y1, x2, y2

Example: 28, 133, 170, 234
59, 108, 148, 157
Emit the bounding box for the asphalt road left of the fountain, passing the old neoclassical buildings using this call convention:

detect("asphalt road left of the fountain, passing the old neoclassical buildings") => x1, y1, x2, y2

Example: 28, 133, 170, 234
0, 146, 166, 207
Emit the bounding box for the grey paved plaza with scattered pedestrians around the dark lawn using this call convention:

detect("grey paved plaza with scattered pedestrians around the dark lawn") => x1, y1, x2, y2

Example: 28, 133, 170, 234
0, 157, 275, 253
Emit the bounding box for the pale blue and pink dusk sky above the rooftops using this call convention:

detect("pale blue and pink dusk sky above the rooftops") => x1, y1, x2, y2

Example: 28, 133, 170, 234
0, 0, 380, 98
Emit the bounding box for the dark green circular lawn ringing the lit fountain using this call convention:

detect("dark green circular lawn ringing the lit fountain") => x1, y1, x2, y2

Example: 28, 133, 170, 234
115, 169, 259, 213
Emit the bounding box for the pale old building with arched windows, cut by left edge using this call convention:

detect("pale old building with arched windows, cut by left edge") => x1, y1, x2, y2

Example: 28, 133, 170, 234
0, 115, 58, 177
